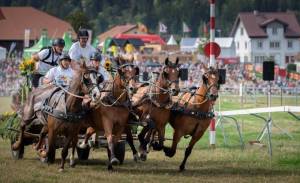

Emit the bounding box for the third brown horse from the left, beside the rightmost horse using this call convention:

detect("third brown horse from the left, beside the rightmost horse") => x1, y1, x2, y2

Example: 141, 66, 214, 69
133, 58, 180, 161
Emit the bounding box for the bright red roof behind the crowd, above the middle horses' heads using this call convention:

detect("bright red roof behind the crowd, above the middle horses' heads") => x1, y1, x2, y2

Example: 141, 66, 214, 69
115, 34, 166, 45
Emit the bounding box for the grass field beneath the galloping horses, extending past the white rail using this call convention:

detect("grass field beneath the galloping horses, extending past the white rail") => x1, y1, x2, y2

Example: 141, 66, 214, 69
0, 96, 300, 183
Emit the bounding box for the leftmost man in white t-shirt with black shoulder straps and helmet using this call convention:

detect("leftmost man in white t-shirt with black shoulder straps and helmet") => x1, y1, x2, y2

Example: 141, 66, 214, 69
32, 38, 65, 88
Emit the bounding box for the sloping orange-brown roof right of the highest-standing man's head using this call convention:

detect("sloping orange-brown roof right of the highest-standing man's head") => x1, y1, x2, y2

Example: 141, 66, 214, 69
98, 24, 138, 42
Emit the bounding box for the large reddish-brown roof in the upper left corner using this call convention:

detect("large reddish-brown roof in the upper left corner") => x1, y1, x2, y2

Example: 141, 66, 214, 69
0, 7, 75, 40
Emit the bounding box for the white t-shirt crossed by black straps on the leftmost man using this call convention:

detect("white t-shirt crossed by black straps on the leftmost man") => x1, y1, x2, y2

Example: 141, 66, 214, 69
36, 48, 60, 75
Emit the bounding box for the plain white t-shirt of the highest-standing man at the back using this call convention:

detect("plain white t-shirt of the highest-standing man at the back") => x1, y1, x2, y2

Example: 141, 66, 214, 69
69, 41, 96, 61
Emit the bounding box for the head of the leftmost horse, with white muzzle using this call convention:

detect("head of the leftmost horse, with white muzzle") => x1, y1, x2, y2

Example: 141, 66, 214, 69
74, 62, 103, 102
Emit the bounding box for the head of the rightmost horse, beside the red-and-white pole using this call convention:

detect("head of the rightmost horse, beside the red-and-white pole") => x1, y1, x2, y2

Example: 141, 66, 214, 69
202, 66, 220, 101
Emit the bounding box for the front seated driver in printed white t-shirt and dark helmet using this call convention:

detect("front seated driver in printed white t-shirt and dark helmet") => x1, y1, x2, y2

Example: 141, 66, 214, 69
43, 54, 73, 87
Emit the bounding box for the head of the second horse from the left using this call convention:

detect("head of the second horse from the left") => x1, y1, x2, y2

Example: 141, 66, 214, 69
117, 58, 139, 96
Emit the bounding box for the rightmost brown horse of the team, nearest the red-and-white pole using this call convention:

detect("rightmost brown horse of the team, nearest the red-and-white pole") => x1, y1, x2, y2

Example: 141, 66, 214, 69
164, 65, 219, 171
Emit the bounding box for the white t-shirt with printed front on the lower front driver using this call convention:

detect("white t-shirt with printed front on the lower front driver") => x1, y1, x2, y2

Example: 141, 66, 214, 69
45, 66, 73, 86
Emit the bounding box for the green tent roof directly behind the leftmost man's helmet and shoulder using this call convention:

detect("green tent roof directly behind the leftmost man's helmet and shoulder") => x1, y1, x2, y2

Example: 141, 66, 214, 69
23, 34, 51, 59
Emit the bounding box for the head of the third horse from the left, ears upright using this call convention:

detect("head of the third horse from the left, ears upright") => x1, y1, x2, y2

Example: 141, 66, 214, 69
160, 58, 180, 95
